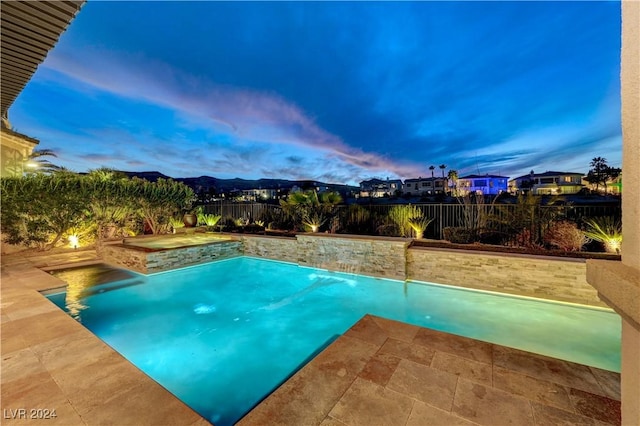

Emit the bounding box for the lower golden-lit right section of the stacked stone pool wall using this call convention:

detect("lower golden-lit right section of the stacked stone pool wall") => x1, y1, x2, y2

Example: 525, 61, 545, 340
407, 248, 606, 307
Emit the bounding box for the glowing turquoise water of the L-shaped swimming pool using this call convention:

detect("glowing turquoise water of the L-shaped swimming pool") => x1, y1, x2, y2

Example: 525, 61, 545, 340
48, 257, 620, 425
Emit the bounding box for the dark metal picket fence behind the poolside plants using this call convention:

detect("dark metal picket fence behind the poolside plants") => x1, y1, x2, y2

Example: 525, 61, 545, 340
203, 202, 622, 239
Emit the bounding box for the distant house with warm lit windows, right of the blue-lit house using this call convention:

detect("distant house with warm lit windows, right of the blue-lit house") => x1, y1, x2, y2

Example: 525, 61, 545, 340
509, 170, 584, 195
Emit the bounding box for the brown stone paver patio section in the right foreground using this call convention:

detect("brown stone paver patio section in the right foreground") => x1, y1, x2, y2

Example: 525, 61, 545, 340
239, 315, 620, 426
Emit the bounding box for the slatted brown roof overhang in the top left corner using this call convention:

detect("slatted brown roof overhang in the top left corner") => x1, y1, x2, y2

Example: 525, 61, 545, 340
0, 0, 86, 118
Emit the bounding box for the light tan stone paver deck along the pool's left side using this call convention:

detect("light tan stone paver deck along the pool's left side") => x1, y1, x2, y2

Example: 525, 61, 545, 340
0, 251, 205, 426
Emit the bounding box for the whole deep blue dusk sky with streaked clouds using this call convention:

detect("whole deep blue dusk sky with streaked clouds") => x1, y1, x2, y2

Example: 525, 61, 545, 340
9, 1, 622, 184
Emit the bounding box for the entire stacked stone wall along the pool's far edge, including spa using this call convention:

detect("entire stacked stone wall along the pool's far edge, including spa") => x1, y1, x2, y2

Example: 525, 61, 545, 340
102, 234, 606, 306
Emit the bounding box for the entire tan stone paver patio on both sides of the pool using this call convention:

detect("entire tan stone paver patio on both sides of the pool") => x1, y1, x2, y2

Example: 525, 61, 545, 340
0, 251, 620, 426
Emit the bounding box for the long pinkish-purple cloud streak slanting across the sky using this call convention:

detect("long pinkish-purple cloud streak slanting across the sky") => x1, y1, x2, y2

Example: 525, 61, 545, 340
37, 50, 420, 183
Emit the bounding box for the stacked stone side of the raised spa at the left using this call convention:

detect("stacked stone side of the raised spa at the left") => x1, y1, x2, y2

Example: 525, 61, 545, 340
101, 241, 243, 274
